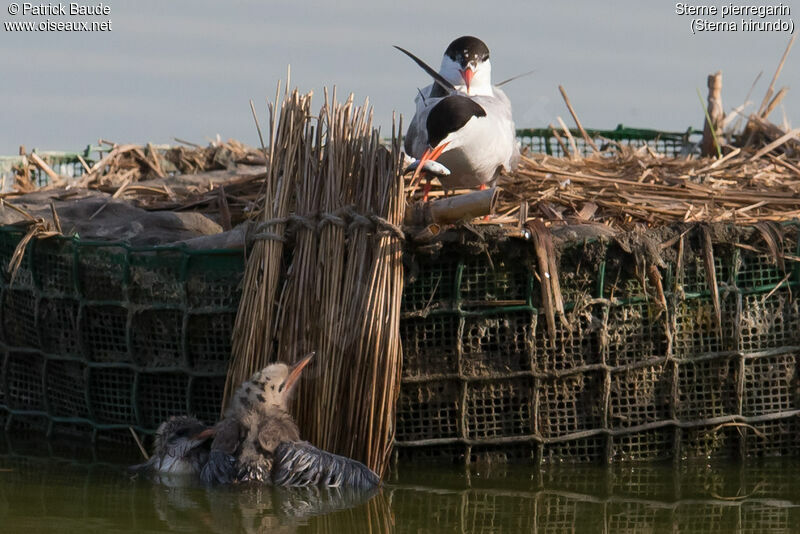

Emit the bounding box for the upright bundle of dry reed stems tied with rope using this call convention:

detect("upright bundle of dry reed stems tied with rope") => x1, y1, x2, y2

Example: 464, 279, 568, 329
226, 82, 405, 473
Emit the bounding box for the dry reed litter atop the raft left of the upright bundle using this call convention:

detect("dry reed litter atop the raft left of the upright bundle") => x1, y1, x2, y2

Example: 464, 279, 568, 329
0, 139, 266, 230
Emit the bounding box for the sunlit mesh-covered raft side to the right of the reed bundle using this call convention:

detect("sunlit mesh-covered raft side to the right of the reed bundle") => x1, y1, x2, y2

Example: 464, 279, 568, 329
396, 225, 800, 463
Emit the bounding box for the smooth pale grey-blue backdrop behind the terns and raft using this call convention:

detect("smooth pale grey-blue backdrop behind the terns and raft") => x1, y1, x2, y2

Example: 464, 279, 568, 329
0, 0, 800, 154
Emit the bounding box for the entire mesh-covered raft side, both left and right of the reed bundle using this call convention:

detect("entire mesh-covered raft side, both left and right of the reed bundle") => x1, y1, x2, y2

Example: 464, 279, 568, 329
0, 222, 800, 463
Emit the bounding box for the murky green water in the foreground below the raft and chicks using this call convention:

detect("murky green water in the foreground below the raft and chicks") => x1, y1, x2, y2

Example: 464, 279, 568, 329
0, 442, 800, 533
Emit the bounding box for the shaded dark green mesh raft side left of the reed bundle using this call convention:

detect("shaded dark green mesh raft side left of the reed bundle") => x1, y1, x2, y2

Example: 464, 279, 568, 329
0, 227, 244, 440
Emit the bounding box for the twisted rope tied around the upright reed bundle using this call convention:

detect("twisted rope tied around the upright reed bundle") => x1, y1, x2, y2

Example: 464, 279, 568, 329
250, 207, 406, 243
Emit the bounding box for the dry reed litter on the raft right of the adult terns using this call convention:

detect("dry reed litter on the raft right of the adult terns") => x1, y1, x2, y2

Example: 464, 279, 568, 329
494, 127, 800, 230
